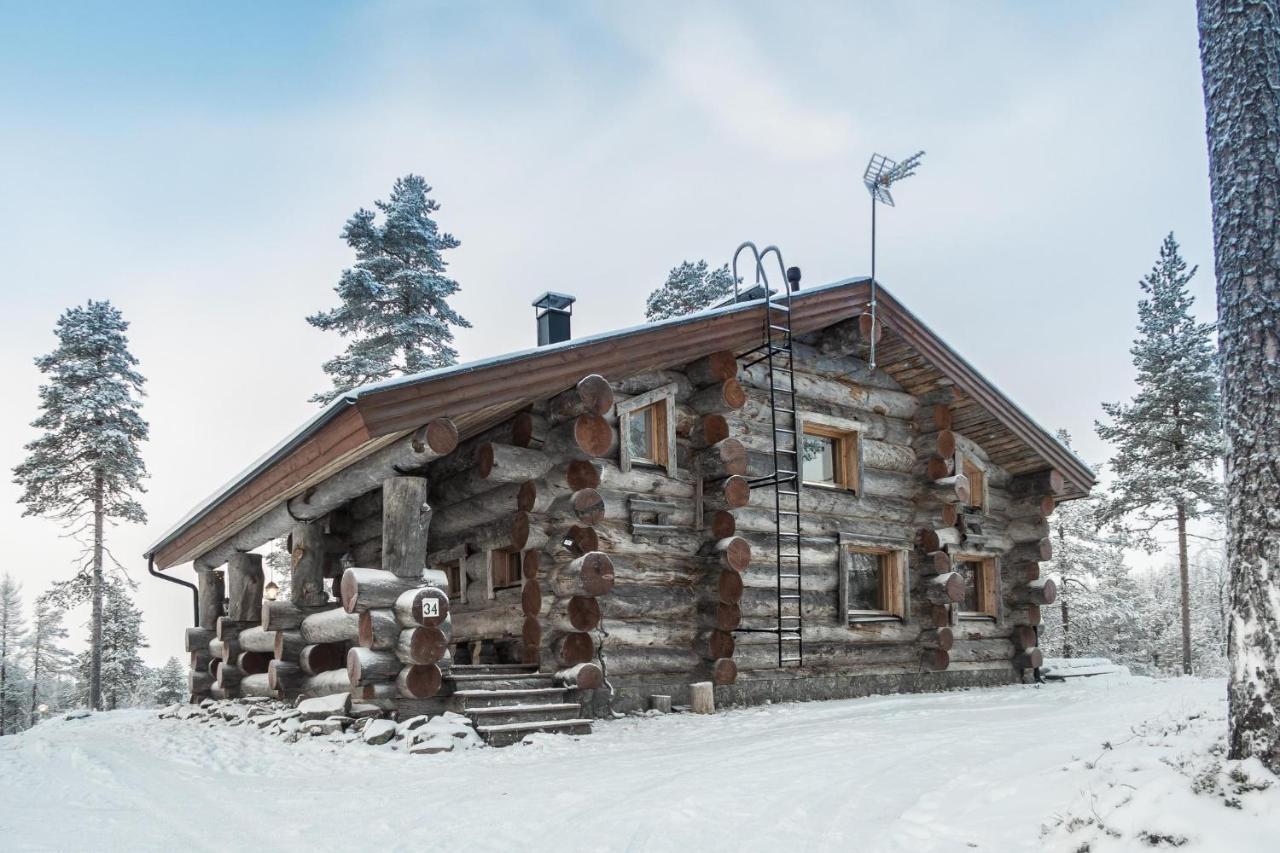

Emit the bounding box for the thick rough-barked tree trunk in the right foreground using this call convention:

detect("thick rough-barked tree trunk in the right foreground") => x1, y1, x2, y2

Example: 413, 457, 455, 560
1198, 0, 1280, 772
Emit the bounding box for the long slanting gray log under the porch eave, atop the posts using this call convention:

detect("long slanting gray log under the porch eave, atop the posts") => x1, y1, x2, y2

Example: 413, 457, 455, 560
197, 418, 458, 567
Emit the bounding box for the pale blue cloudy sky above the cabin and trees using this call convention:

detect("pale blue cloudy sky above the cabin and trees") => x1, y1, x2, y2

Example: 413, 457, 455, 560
0, 1, 1212, 660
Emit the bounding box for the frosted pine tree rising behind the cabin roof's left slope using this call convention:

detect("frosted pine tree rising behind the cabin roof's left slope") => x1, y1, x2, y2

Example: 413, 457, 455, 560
307, 174, 471, 403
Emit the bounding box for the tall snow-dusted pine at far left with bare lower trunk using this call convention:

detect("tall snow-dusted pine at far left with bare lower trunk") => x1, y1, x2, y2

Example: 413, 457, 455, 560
14, 300, 147, 710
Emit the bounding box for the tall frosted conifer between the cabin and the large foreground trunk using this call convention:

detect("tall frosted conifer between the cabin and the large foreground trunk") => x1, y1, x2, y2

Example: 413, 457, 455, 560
1097, 234, 1222, 674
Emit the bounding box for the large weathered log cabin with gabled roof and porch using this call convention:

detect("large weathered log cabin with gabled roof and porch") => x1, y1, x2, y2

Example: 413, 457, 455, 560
146, 270, 1093, 743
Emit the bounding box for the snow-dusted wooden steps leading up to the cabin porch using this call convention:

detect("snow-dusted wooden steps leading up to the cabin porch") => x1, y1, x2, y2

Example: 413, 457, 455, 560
445, 663, 591, 747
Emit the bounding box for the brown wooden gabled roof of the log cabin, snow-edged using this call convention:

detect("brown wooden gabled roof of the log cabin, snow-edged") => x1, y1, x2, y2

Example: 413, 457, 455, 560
146, 279, 1093, 569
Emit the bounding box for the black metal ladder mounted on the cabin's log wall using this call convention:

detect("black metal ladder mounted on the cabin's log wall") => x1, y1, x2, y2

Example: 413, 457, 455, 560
733, 243, 804, 667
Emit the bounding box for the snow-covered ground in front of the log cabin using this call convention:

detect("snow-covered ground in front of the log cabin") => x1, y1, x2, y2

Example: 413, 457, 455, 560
0, 676, 1280, 853
